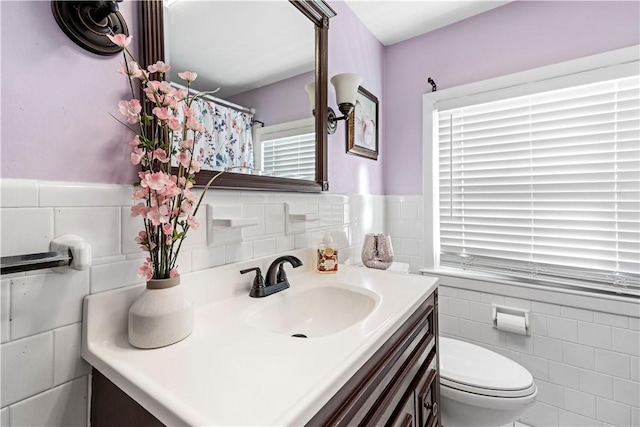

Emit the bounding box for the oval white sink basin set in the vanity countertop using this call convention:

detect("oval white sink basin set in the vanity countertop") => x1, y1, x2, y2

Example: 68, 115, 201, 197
242, 285, 380, 338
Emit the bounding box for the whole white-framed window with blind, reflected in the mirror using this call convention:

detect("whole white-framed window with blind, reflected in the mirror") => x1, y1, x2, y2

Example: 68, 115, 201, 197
256, 118, 316, 181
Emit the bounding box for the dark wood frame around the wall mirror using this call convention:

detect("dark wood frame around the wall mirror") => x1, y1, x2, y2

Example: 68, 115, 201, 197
139, 0, 336, 192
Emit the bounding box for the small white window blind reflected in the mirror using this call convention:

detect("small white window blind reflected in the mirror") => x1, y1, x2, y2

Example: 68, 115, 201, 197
262, 133, 316, 180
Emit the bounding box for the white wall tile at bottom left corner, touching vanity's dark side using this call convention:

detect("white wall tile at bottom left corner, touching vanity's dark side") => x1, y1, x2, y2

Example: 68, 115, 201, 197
11, 377, 88, 427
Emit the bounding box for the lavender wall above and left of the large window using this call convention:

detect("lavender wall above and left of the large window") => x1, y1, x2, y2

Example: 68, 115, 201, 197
383, 1, 640, 195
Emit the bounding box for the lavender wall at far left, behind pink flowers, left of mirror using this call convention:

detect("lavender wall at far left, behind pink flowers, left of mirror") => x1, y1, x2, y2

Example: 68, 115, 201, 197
0, 1, 137, 183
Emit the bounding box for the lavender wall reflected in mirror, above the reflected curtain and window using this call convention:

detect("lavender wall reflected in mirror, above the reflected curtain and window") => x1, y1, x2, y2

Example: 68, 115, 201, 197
229, 71, 315, 126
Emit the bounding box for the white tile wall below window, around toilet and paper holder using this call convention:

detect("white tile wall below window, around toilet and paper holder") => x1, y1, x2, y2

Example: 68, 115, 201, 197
386, 196, 640, 427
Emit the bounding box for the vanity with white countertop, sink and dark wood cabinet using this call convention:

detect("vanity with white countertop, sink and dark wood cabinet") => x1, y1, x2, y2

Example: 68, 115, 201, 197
82, 250, 440, 426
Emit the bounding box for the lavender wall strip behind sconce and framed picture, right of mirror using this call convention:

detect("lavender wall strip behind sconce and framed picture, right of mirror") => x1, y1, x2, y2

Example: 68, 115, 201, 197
328, 1, 387, 194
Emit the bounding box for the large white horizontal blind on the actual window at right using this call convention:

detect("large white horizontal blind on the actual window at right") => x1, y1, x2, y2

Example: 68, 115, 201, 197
436, 75, 640, 295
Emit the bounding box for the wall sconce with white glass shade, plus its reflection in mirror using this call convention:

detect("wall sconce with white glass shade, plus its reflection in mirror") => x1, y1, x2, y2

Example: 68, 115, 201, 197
304, 73, 362, 135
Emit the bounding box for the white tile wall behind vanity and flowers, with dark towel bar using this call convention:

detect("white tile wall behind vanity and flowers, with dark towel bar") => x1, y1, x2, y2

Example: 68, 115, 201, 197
0, 179, 385, 426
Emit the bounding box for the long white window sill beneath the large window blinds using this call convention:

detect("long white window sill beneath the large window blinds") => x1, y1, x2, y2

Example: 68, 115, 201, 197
420, 268, 640, 317
